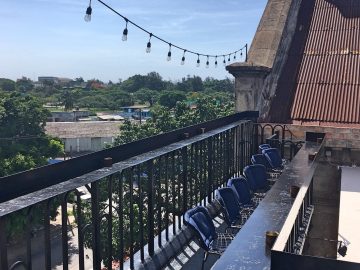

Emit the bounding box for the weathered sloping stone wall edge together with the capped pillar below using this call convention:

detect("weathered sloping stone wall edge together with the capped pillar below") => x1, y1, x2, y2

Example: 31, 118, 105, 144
226, 0, 299, 112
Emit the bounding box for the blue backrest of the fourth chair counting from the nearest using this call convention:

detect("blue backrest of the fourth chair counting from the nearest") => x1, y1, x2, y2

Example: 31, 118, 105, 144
244, 164, 269, 191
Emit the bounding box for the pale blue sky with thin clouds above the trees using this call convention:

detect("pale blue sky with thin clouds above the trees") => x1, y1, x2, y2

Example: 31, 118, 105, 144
0, 0, 267, 81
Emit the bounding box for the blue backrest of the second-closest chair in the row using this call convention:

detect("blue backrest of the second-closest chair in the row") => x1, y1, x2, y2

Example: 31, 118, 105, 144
215, 187, 241, 226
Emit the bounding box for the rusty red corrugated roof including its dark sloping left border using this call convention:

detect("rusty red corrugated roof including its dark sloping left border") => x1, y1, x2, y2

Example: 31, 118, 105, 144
270, 0, 360, 125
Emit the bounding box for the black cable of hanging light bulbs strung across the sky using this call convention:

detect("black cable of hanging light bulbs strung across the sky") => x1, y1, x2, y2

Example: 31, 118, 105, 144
84, 0, 248, 68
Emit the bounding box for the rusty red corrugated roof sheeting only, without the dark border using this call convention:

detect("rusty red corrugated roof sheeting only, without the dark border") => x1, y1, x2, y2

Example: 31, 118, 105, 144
290, 0, 360, 123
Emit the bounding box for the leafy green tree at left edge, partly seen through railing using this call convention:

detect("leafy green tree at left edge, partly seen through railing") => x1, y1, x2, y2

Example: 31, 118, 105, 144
0, 92, 64, 241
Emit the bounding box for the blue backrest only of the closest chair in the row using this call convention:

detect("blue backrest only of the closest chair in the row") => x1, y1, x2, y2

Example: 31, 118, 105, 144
184, 206, 217, 250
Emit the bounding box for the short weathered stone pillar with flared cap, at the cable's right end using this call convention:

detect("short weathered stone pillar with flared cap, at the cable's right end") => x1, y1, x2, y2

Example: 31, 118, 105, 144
226, 63, 271, 112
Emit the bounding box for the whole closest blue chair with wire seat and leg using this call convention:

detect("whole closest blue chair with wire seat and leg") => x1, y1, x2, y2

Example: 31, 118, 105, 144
184, 206, 234, 269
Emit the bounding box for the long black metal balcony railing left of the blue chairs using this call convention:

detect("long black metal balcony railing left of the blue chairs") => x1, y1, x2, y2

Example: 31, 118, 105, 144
0, 113, 257, 269
